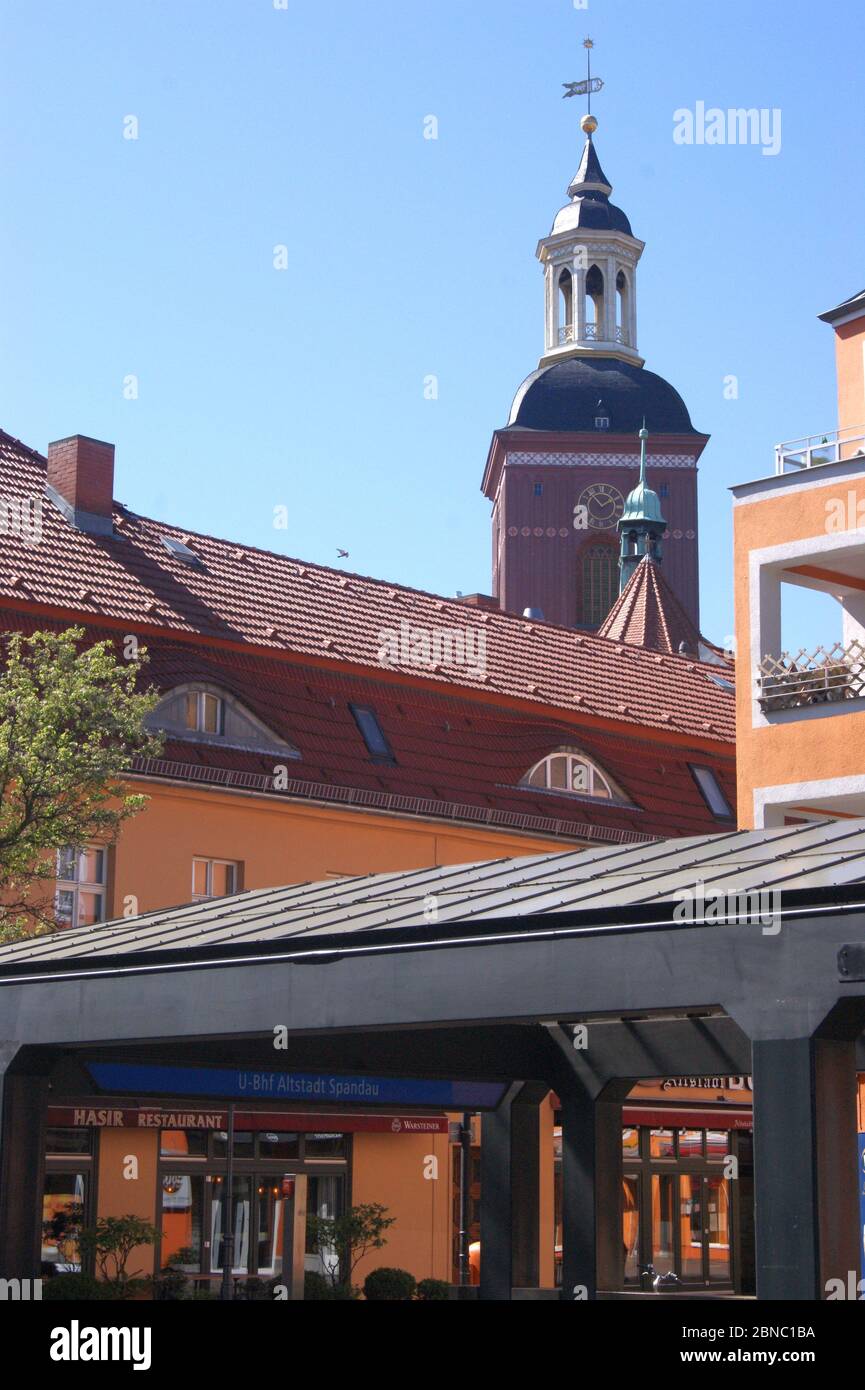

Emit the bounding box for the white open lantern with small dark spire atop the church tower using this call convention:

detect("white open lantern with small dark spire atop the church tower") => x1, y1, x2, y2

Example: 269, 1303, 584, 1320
537, 115, 645, 367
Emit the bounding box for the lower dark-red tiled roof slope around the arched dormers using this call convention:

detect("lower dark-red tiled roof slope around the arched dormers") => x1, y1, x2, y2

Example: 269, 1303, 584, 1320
3, 617, 736, 838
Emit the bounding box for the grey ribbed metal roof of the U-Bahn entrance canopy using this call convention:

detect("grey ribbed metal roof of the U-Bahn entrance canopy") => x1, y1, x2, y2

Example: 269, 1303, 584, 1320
0, 820, 865, 974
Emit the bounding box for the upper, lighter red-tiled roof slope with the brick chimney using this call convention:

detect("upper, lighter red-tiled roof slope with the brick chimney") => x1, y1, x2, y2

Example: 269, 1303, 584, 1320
0, 432, 734, 745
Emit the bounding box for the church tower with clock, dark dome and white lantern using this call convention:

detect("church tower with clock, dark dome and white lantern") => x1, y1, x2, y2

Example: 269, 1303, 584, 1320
483, 85, 708, 631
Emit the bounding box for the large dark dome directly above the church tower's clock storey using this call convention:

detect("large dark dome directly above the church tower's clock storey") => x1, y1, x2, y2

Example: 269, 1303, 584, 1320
508, 357, 697, 434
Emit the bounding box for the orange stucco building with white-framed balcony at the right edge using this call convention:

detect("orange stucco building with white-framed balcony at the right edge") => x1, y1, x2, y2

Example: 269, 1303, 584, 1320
733, 283, 865, 827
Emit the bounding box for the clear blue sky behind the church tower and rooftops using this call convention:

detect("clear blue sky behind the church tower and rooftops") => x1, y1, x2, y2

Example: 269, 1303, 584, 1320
0, 0, 865, 641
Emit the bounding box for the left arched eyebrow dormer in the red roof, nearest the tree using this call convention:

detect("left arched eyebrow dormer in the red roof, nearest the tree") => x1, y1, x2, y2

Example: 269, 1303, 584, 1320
146, 681, 300, 758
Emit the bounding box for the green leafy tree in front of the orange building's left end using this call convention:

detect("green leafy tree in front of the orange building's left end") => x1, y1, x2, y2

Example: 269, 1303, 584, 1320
0, 627, 161, 941
